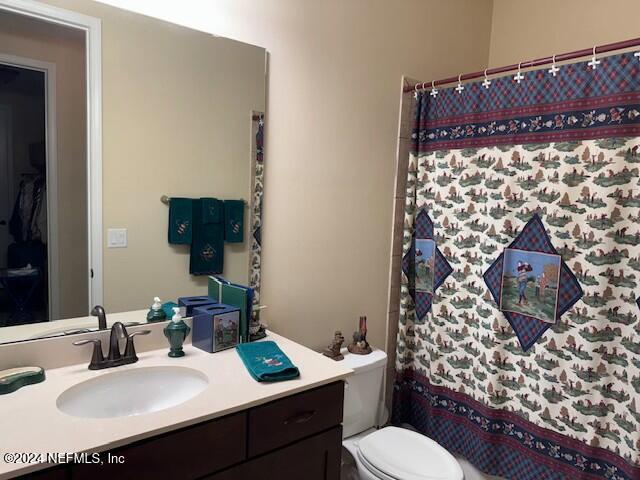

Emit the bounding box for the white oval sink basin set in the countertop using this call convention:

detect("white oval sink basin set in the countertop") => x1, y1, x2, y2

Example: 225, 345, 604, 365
56, 367, 209, 418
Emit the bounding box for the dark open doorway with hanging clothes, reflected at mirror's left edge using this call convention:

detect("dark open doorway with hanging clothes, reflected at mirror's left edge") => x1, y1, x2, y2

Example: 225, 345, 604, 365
0, 62, 51, 325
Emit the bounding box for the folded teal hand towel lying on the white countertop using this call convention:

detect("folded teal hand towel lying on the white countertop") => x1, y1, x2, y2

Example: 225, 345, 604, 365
236, 341, 300, 382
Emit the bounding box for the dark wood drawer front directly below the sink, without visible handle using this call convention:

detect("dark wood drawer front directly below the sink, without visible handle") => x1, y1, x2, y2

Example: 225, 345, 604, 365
72, 412, 247, 480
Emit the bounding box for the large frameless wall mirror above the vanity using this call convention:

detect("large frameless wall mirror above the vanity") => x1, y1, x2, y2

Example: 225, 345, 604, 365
0, 0, 266, 344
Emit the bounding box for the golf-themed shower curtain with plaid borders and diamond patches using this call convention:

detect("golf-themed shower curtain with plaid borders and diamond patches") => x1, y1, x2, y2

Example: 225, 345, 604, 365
393, 53, 640, 480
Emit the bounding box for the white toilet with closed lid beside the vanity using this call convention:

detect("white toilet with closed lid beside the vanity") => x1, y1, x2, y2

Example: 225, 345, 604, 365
342, 349, 464, 480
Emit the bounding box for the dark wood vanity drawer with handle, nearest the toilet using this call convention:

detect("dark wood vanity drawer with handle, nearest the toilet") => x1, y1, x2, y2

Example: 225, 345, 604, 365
248, 382, 344, 457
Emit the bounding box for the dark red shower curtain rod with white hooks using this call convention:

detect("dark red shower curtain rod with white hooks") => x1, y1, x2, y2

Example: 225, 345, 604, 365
403, 38, 640, 92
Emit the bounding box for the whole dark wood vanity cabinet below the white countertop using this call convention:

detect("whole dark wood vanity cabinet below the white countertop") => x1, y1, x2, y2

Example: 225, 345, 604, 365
22, 382, 344, 480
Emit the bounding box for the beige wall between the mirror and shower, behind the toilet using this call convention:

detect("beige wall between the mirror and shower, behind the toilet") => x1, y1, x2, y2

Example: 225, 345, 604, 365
89, 0, 491, 348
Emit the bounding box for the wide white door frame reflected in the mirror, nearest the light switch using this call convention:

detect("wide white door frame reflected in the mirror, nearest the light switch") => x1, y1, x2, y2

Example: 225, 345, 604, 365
0, 0, 103, 314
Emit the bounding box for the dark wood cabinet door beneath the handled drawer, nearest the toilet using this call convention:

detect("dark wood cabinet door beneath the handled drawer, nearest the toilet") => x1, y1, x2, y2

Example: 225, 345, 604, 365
206, 426, 342, 480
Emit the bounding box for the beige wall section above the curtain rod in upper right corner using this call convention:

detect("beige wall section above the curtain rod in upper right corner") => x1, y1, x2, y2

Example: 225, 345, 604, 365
489, 0, 640, 67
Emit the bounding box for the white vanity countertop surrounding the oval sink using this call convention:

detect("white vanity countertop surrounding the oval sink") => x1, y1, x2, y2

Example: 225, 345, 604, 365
0, 332, 352, 479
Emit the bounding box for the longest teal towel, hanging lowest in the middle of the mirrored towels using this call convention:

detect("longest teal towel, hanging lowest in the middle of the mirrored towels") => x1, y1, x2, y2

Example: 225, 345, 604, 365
189, 199, 224, 275
